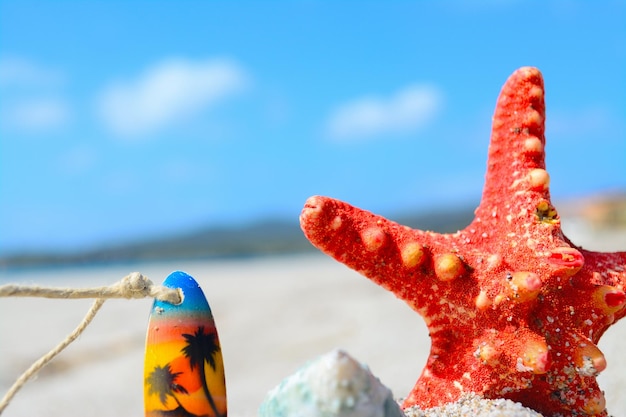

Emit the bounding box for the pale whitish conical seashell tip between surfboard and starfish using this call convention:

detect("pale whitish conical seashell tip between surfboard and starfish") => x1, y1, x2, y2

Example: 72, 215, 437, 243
258, 350, 404, 417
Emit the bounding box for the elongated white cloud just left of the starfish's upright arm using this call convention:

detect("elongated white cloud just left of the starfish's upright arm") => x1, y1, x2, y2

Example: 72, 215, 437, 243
328, 85, 442, 140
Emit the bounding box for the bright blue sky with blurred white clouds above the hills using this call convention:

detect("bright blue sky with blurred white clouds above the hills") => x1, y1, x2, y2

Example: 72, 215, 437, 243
0, 0, 626, 253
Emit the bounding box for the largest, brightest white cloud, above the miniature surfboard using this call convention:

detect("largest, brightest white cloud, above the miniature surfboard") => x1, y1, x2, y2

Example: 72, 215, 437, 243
98, 59, 246, 137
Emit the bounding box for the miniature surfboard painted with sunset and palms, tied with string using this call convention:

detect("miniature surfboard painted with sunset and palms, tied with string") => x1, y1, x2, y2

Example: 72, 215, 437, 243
144, 271, 226, 417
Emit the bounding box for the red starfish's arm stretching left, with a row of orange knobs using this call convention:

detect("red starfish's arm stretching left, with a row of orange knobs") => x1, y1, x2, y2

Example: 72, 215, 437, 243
300, 196, 430, 301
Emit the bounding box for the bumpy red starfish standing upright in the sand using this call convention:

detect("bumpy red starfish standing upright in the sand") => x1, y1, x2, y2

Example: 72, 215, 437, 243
300, 67, 626, 416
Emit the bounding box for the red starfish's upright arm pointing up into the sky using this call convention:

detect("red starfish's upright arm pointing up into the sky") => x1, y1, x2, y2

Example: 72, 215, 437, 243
466, 67, 585, 285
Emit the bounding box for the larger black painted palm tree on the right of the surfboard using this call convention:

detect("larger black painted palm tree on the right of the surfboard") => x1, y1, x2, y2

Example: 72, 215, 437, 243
182, 326, 226, 417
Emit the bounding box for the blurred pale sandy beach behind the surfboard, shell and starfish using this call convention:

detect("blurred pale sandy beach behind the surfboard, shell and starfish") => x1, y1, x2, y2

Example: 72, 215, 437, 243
0, 219, 626, 417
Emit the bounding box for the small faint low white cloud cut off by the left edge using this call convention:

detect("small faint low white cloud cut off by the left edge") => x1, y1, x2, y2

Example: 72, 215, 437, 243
0, 98, 70, 132
